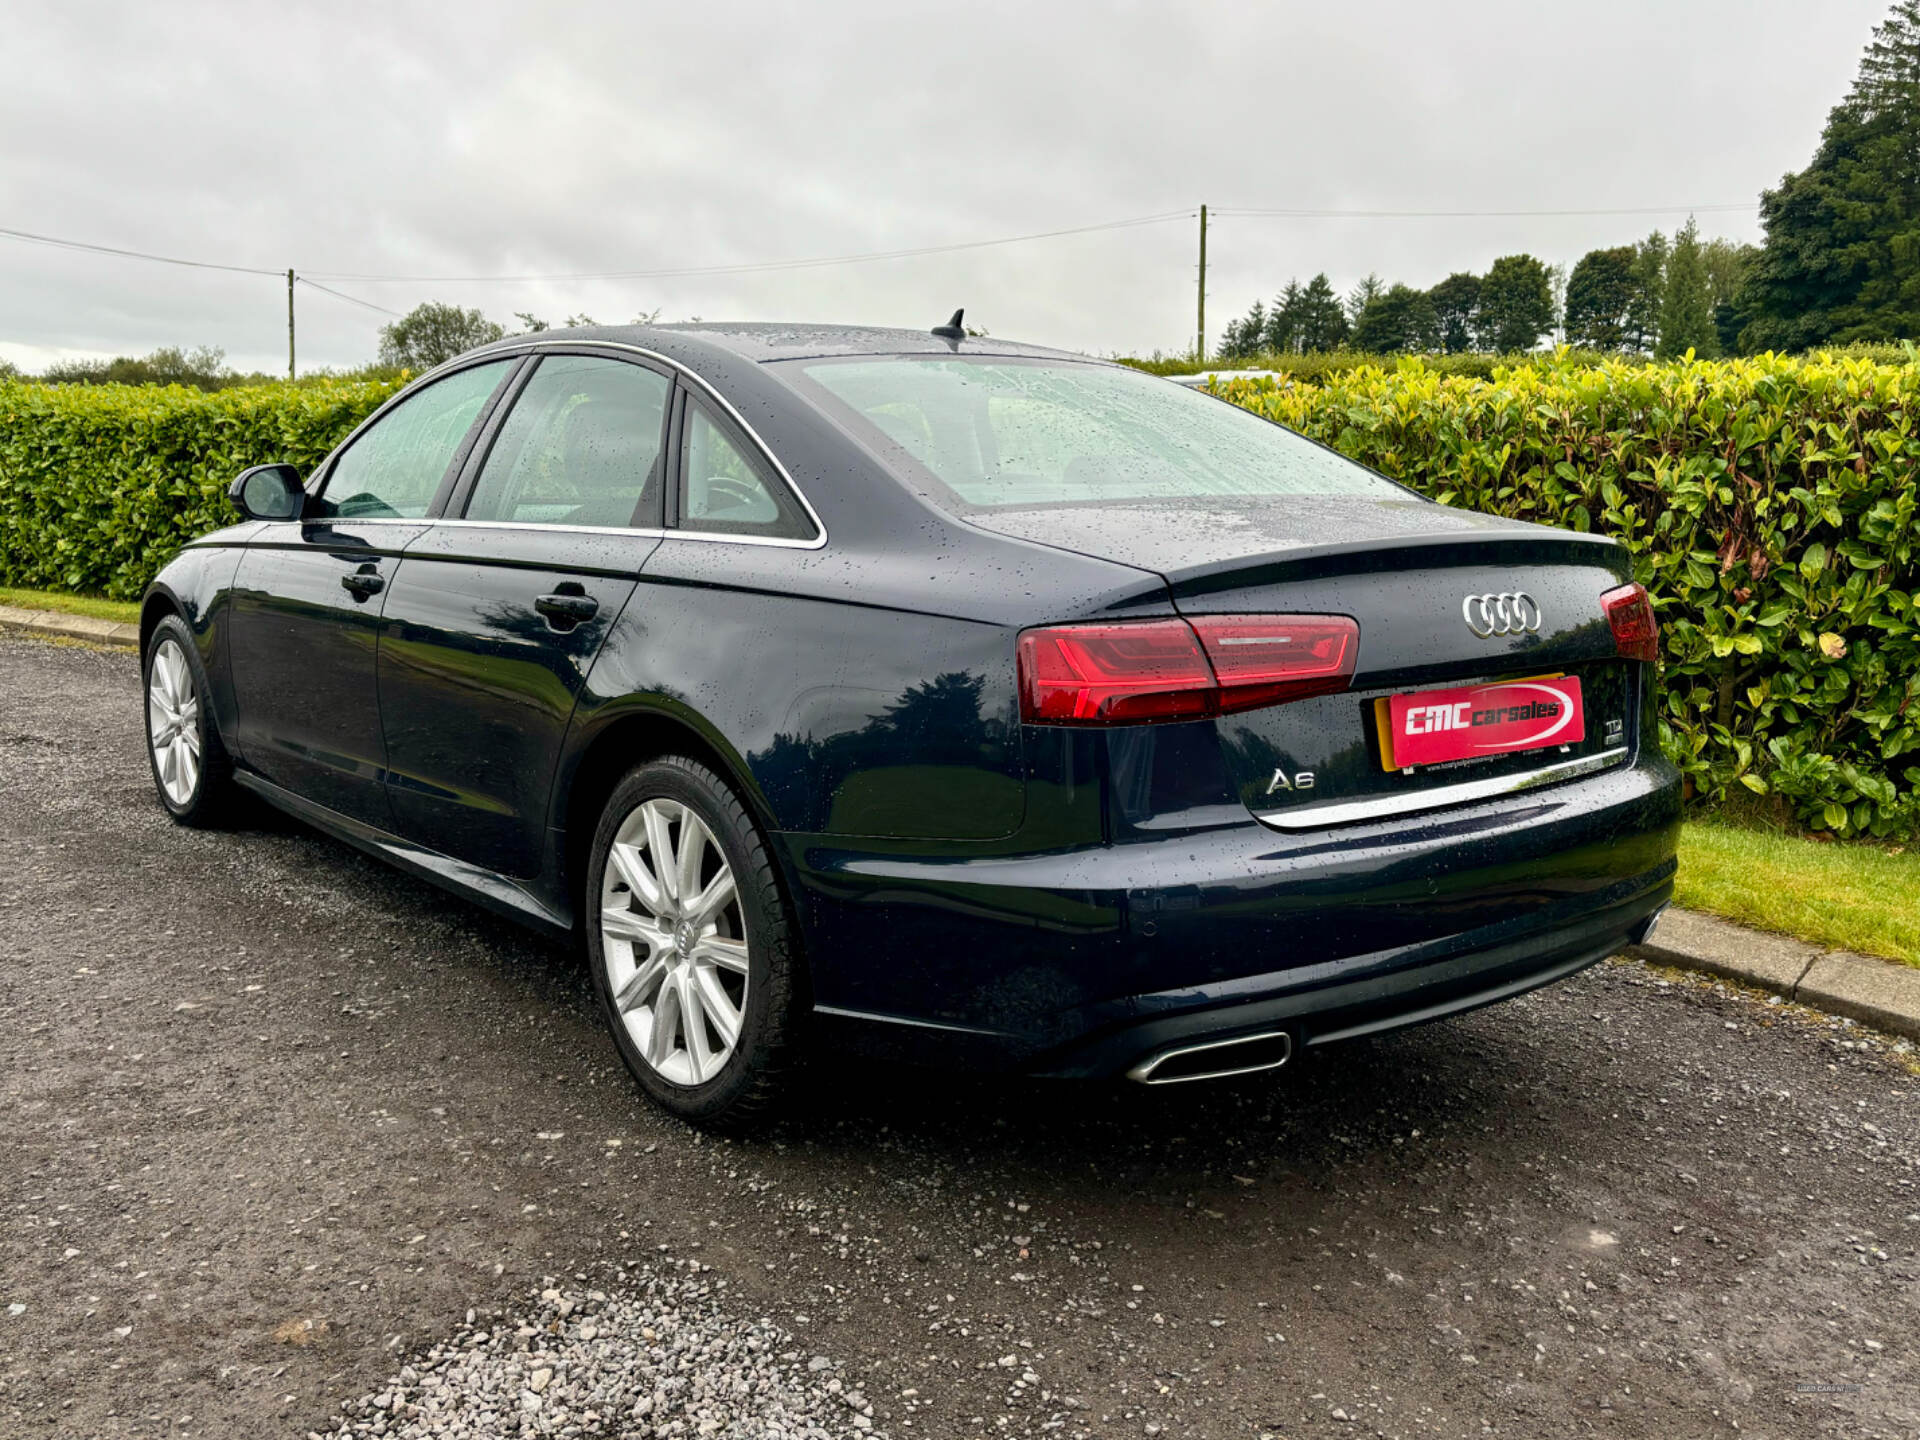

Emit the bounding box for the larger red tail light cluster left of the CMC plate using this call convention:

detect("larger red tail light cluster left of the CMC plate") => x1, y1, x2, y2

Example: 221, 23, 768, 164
1020, 614, 1359, 726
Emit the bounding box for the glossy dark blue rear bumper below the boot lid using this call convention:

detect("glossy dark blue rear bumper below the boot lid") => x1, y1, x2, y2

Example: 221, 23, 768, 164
783, 758, 1680, 1075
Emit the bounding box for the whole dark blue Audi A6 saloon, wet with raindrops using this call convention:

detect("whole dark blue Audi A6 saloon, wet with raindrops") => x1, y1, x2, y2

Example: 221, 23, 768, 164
140, 317, 1680, 1123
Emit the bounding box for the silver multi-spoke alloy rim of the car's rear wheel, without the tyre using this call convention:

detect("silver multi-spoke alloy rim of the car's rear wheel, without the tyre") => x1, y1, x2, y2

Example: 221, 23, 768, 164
601, 799, 747, 1085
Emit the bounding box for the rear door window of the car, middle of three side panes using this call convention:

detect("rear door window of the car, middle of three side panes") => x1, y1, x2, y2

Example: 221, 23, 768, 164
467, 355, 672, 528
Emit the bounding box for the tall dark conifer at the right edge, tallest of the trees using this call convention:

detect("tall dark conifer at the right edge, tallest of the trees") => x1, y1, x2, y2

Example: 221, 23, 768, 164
1738, 0, 1920, 351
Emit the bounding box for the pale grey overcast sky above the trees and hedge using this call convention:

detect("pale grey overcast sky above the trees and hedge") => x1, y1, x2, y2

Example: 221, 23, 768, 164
0, 0, 1885, 369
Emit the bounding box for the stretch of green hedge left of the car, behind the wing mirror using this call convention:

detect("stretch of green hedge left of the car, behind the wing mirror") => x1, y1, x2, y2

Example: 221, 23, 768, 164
0, 380, 401, 599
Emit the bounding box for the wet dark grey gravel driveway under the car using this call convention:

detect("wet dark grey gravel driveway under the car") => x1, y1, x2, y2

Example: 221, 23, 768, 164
0, 639, 1920, 1440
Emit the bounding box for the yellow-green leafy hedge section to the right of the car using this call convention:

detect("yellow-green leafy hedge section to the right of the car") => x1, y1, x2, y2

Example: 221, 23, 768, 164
1219, 353, 1920, 837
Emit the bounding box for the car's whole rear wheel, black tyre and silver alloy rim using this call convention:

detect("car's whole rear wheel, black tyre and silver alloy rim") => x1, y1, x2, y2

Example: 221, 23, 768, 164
586, 756, 795, 1127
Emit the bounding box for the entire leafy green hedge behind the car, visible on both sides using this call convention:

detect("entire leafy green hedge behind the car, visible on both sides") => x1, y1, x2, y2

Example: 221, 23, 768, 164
0, 351, 1920, 835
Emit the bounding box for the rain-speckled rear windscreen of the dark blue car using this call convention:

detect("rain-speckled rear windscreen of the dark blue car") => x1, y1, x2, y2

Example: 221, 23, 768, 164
801, 355, 1405, 509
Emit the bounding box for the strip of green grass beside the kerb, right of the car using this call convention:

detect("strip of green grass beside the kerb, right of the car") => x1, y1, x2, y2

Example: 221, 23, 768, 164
1674, 820, 1920, 966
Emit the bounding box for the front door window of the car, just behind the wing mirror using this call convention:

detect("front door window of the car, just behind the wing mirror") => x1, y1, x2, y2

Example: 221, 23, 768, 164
324, 359, 515, 520
